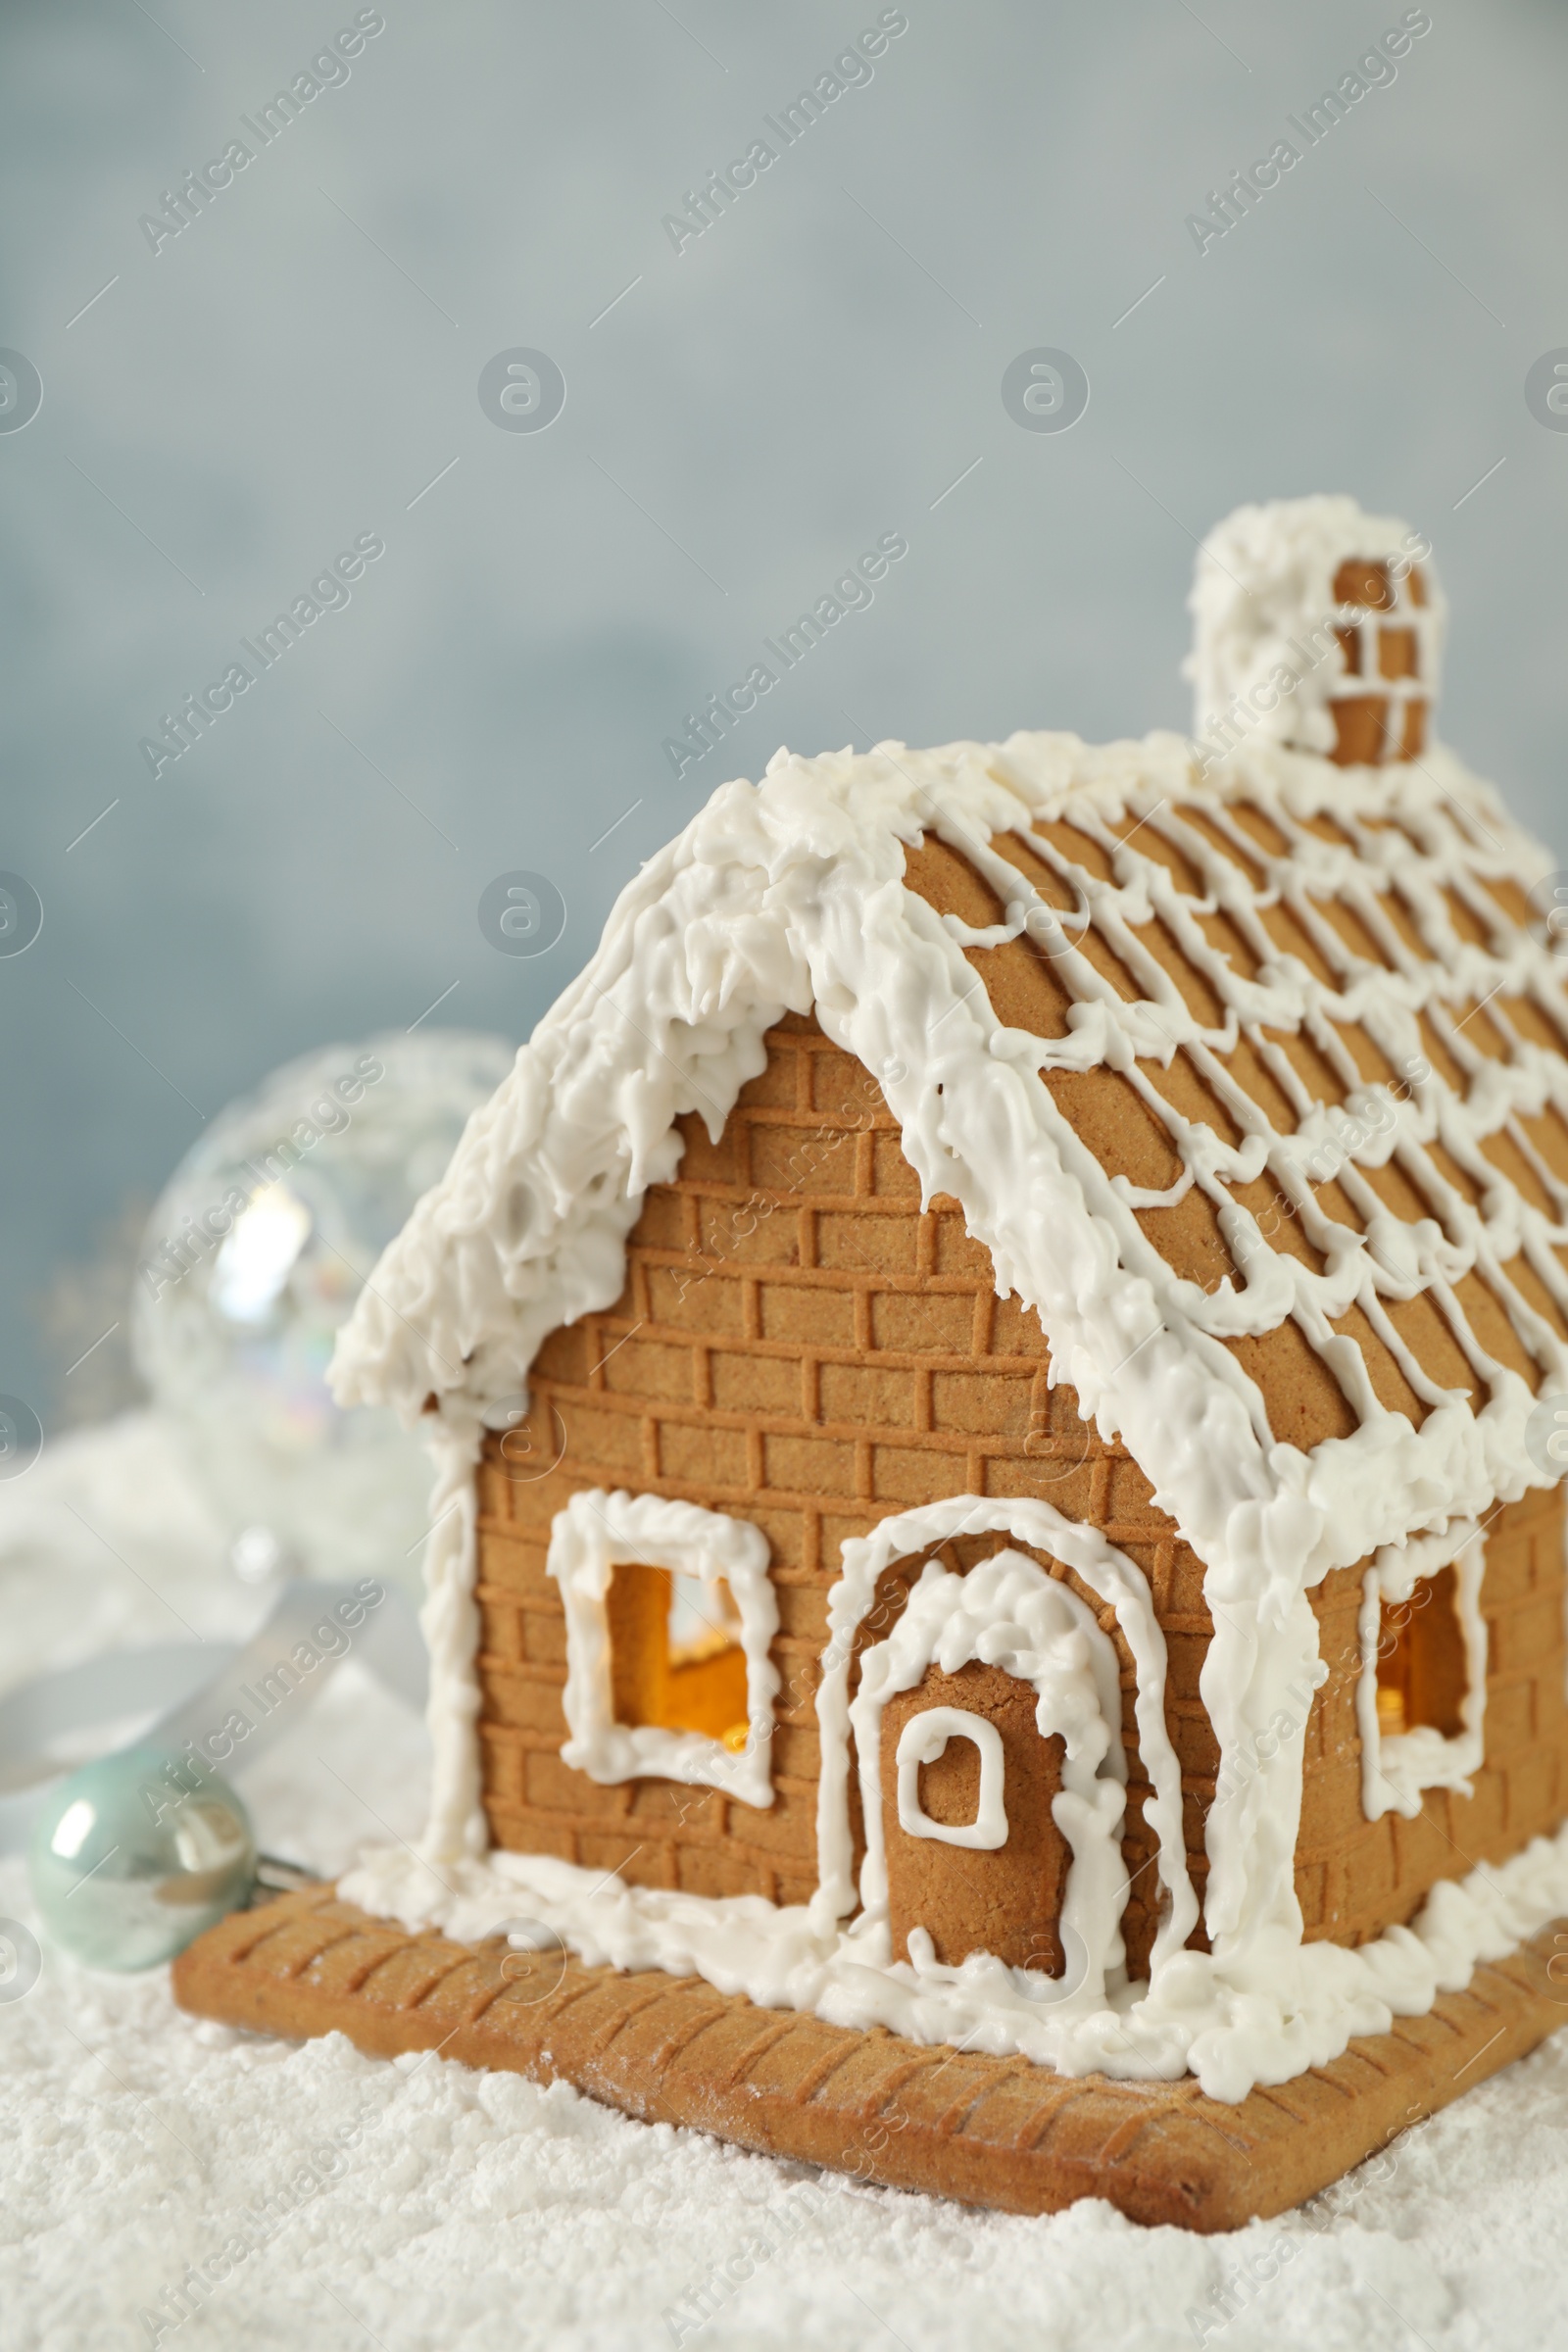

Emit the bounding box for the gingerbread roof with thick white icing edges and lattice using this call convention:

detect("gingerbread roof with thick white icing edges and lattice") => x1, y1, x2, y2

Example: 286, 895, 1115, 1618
334, 501, 1568, 1609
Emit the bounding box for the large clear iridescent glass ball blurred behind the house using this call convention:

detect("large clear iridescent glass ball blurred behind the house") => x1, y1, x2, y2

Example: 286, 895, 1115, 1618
131, 1030, 514, 1586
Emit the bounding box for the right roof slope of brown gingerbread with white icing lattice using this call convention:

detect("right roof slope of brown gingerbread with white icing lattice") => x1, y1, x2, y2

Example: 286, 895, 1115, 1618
912, 755, 1568, 1437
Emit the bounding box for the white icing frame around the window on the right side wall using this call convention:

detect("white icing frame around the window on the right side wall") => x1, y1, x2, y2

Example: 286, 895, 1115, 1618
1356, 1519, 1486, 1821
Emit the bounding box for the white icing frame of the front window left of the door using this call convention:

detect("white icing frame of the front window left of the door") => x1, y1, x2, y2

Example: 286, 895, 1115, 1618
546, 1487, 778, 1806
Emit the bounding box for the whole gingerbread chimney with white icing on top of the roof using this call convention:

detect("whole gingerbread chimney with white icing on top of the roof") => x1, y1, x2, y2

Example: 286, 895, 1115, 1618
1185, 496, 1446, 766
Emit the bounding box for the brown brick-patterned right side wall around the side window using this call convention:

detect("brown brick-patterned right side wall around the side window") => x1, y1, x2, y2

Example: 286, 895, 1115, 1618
1296, 1487, 1568, 1942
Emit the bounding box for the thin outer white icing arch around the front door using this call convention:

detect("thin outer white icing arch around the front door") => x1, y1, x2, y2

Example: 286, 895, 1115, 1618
811, 1494, 1199, 1976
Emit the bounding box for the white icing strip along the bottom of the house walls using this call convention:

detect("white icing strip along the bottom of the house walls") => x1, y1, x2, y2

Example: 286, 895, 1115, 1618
338, 1828, 1568, 2103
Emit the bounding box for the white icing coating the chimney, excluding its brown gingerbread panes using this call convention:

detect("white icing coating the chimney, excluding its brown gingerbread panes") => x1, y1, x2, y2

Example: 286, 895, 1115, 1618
1187, 499, 1446, 753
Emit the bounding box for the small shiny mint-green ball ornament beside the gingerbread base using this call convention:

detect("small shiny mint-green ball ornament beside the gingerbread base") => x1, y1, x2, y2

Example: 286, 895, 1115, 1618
30, 1747, 256, 1969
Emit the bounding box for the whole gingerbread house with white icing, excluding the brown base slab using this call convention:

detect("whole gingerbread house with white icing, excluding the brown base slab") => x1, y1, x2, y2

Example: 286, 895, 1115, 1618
319, 499, 1568, 2100
